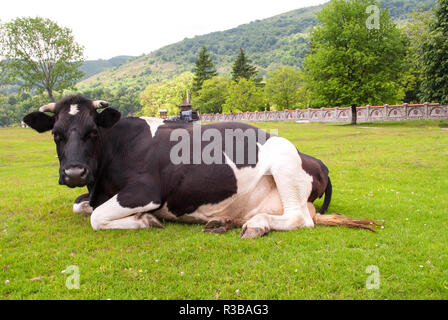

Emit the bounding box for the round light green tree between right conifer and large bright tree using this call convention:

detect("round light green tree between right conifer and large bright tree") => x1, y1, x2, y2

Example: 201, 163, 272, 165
265, 66, 303, 110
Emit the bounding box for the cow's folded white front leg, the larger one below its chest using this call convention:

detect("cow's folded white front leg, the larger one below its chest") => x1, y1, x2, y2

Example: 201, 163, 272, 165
90, 194, 162, 231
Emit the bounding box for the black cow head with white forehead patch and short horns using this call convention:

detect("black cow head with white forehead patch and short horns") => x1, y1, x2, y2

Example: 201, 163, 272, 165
23, 95, 121, 188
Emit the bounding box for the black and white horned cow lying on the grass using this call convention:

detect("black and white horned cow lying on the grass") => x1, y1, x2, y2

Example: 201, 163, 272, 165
23, 95, 375, 238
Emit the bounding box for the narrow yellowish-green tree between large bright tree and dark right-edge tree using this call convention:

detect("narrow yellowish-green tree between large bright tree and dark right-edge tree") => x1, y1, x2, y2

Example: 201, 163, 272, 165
403, 8, 433, 103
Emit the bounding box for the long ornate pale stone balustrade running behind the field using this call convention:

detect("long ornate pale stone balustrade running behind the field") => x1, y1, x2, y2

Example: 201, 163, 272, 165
200, 103, 448, 122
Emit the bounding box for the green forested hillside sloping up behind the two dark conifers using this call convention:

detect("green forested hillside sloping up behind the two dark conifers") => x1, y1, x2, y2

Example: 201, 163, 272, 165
80, 0, 435, 90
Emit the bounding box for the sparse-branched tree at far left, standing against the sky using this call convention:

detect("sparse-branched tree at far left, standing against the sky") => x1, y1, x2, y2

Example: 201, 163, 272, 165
0, 17, 84, 101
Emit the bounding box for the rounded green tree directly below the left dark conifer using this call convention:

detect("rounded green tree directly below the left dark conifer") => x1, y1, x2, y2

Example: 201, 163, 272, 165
193, 76, 230, 113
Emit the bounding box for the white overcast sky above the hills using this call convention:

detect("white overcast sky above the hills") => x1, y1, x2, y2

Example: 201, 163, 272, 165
0, 0, 328, 59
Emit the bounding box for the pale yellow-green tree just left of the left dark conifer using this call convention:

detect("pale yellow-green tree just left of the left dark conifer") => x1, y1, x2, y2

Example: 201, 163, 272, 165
138, 72, 193, 116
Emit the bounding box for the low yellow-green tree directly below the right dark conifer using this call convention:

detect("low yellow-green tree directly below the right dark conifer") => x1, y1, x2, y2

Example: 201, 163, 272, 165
222, 78, 265, 113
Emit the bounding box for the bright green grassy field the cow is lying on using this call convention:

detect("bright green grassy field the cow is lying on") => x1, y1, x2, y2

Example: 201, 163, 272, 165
0, 121, 448, 299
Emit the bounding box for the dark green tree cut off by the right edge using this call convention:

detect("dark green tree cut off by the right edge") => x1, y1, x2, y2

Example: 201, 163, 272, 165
422, 0, 448, 103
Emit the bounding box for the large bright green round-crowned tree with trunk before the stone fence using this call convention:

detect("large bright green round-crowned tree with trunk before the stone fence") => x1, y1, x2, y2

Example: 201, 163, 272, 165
305, 0, 406, 122
